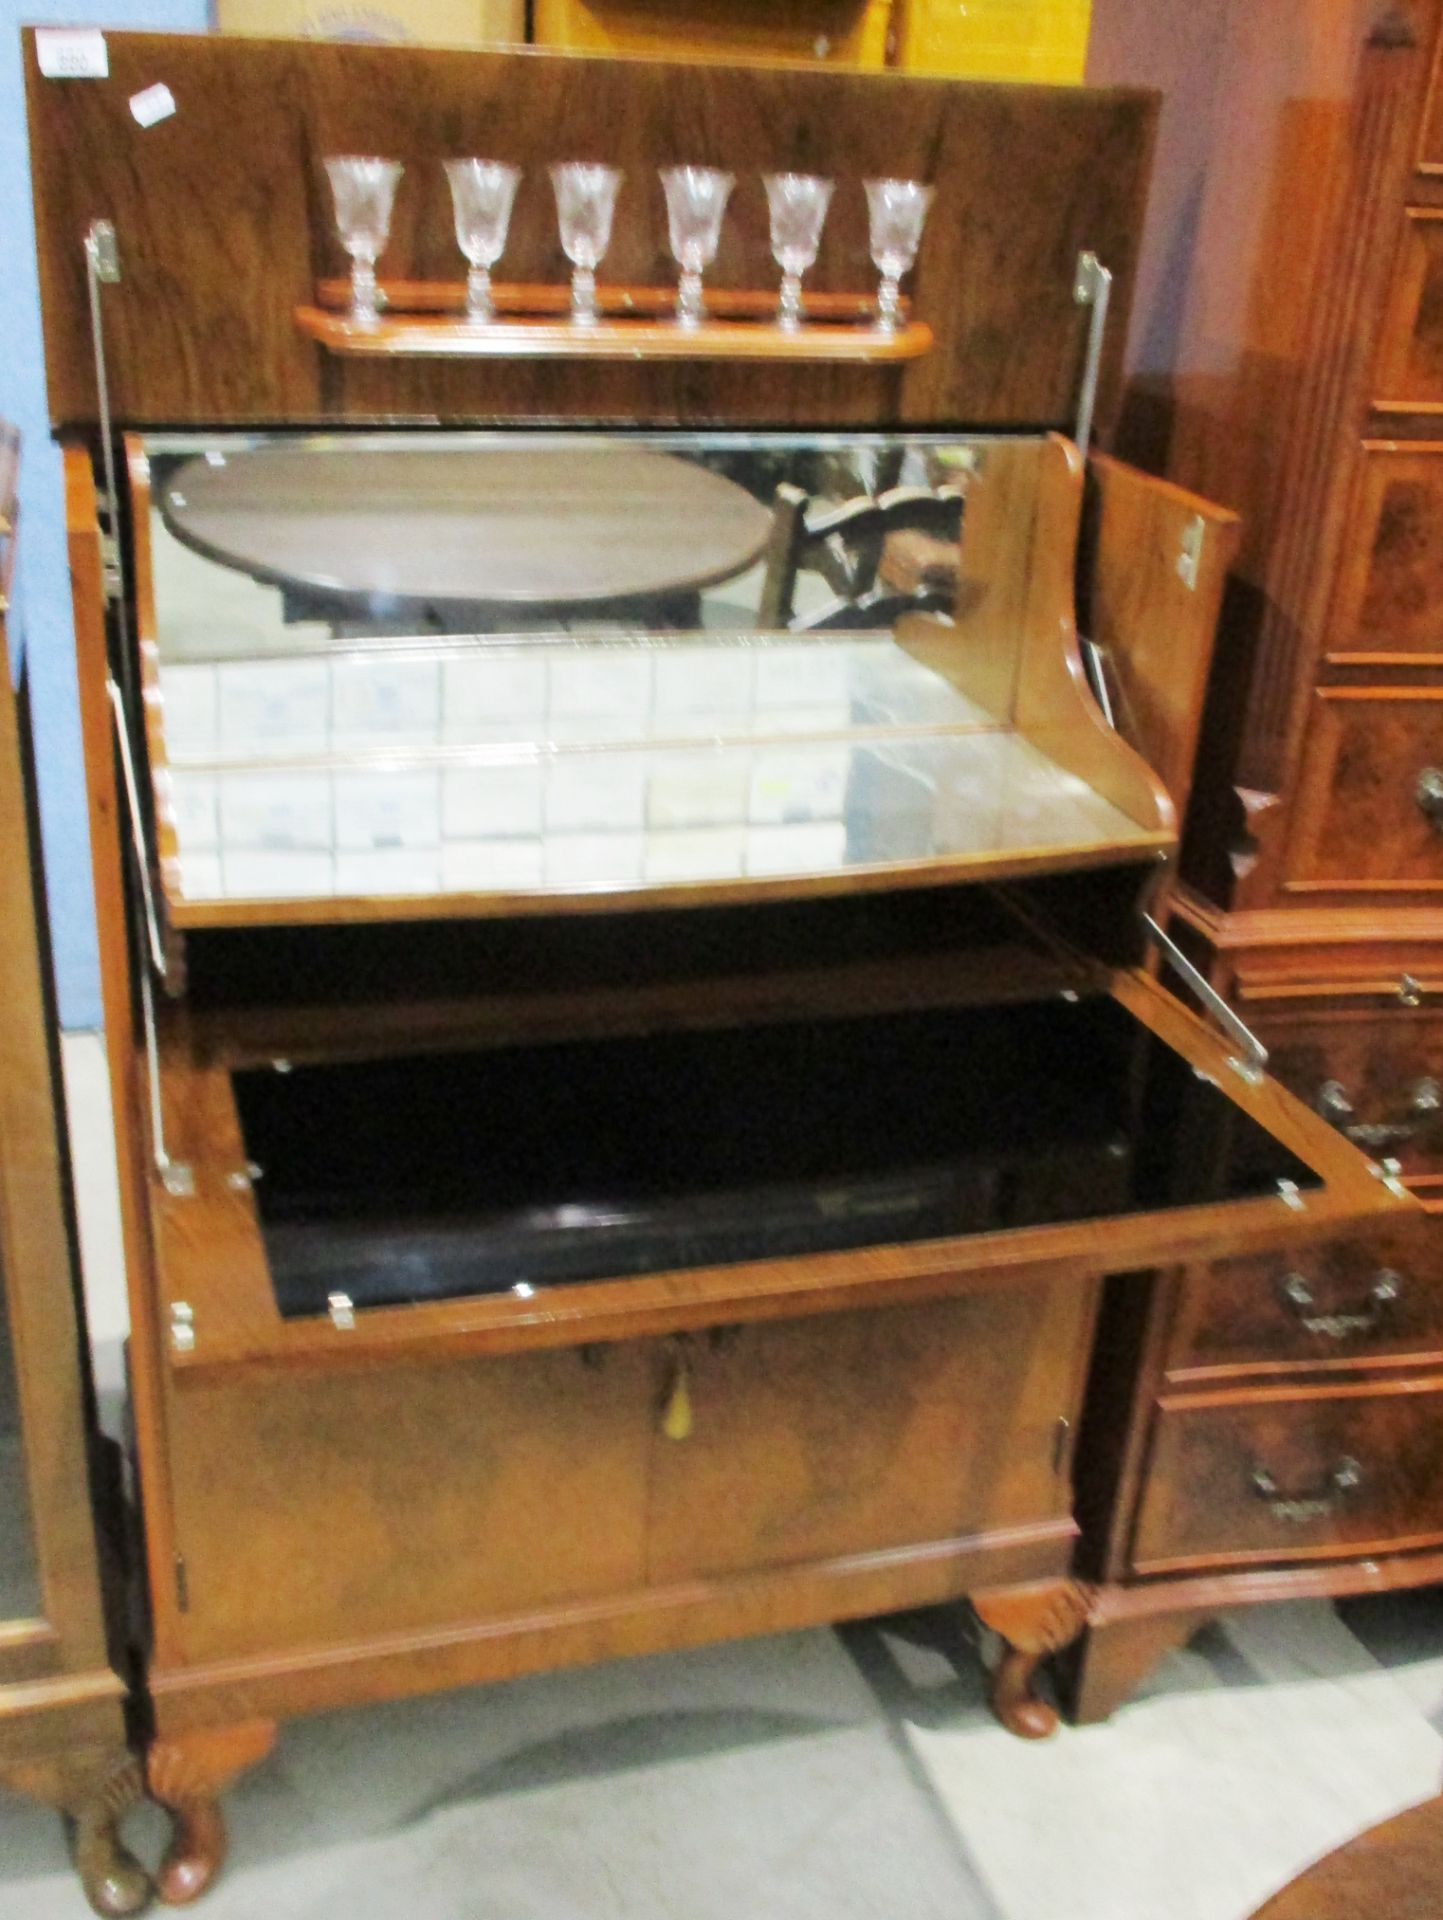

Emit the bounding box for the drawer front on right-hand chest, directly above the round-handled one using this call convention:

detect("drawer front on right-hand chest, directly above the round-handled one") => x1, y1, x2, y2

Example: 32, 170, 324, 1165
1328, 442, 1443, 659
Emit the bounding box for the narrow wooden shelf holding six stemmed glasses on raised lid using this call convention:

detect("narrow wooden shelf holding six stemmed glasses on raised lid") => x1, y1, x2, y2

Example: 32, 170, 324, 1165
296, 280, 933, 365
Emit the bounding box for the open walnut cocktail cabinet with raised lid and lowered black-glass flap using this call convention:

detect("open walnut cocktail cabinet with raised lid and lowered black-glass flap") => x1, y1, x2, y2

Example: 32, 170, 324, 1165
27, 22, 1412, 1899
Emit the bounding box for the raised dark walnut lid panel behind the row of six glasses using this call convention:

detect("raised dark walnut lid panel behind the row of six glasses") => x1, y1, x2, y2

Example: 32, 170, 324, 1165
25, 33, 1155, 426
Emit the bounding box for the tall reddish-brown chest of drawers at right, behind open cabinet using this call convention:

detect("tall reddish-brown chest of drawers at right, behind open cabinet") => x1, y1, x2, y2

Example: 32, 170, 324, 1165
1078, 0, 1443, 1715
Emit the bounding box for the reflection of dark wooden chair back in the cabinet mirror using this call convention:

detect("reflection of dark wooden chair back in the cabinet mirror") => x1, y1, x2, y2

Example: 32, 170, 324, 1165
760, 484, 961, 634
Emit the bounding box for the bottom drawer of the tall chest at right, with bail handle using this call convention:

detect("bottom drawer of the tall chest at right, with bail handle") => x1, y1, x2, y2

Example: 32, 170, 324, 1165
1132, 1377, 1443, 1574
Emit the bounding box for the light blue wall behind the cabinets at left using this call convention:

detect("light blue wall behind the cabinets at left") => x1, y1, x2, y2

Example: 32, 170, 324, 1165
0, 0, 207, 1027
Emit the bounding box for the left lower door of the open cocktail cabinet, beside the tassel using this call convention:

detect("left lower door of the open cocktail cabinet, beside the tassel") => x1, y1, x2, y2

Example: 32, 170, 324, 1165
173, 1346, 656, 1661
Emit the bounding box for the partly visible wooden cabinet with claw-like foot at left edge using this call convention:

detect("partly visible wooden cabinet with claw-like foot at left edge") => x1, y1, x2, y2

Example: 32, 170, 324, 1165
0, 426, 150, 1914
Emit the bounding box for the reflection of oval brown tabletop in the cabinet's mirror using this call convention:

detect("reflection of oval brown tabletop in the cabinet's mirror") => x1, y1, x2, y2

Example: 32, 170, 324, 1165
157, 442, 771, 624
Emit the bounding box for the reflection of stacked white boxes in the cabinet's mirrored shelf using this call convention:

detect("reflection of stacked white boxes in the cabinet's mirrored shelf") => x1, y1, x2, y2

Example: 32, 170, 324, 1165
163, 641, 885, 899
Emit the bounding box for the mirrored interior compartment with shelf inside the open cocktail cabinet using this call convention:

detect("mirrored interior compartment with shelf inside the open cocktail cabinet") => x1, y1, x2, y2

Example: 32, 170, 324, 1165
132, 434, 1174, 920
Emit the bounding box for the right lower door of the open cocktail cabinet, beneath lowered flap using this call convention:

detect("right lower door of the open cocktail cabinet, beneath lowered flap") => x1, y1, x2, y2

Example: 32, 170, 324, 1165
651, 1281, 1096, 1582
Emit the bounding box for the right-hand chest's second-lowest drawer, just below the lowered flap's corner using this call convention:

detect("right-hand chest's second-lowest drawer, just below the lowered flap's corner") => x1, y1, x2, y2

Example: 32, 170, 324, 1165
1167, 1219, 1443, 1380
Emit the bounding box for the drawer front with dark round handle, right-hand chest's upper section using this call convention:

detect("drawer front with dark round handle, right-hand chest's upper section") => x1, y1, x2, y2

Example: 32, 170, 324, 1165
1288, 687, 1443, 893
